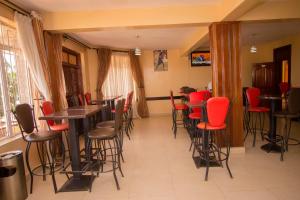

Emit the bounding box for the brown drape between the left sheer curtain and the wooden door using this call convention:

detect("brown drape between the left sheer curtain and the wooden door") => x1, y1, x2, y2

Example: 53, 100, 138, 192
44, 32, 68, 111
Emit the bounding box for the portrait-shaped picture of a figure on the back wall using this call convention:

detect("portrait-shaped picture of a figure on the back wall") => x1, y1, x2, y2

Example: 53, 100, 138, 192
153, 50, 168, 71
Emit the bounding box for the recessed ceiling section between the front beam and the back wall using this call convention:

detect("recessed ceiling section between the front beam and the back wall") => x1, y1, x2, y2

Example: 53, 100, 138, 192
71, 27, 203, 49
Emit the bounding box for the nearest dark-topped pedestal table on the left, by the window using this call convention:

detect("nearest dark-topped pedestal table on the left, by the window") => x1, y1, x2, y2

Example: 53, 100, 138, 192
39, 105, 104, 192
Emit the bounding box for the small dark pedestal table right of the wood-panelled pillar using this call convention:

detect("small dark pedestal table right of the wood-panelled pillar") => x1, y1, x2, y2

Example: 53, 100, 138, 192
258, 95, 282, 153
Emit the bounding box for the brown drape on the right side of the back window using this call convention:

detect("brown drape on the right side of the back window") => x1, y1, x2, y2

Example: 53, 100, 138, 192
129, 51, 149, 117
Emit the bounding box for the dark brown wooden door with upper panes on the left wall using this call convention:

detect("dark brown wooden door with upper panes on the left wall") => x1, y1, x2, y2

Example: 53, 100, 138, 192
63, 47, 83, 107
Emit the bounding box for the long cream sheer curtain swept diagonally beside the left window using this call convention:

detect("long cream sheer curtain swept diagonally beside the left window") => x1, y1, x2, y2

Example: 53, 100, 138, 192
15, 12, 51, 100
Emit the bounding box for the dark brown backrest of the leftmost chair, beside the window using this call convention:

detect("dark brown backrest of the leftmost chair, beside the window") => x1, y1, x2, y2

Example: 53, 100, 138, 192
13, 103, 37, 136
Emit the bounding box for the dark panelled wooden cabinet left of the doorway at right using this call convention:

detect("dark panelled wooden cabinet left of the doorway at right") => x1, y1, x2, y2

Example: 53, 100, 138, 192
252, 62, 277, 94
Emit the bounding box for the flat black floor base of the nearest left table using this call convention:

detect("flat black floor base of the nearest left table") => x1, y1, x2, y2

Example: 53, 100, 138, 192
58, 175, 95, 192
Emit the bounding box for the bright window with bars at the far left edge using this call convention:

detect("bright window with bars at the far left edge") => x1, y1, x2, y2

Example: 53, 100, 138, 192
0, 21, 32, 139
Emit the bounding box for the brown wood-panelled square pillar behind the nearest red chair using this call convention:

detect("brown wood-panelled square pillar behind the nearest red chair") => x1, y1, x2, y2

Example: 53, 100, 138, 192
209, 22, 244, 147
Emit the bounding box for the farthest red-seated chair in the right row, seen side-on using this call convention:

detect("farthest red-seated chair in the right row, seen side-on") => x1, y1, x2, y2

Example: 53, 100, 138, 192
170, 91, 188, 138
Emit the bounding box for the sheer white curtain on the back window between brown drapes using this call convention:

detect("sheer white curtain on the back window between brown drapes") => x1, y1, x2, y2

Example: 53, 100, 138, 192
102, 52, 138, 117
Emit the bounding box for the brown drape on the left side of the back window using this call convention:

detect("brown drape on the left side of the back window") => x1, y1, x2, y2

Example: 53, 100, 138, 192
97, 48, 112, 100
